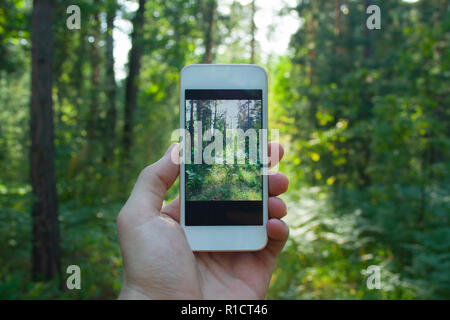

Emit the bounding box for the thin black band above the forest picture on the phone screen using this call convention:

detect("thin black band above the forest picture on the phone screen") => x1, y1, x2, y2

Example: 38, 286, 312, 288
185, 89, 262, 100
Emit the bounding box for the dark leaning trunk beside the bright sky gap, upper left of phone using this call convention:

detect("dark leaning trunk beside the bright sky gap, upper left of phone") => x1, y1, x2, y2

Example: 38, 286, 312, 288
122, 0, 145, 160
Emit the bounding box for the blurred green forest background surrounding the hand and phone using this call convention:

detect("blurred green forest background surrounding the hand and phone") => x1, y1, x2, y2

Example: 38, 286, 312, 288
0, 0, 450, 299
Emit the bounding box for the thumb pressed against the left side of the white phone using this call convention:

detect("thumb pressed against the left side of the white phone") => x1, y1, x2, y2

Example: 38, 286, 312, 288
128, 143, 180, 214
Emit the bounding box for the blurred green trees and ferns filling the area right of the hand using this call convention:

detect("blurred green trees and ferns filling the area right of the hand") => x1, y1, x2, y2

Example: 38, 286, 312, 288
272, 1, 450, 299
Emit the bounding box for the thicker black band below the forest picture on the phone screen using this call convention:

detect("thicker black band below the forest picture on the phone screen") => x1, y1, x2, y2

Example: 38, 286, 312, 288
185, 200, 263, 226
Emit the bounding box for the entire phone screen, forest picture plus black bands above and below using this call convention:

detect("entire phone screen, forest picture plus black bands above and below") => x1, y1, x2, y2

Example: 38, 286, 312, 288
184, 89, 264, 226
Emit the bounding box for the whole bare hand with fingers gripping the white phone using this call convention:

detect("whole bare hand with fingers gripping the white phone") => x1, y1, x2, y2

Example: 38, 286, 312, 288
117, 143, 289, 299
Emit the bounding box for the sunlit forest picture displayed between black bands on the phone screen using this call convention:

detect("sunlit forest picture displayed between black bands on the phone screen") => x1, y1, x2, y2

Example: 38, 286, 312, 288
186, 100, 262, 201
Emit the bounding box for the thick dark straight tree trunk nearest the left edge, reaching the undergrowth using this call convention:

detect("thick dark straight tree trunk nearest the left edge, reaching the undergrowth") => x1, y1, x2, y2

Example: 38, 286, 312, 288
30, 0, 61, 280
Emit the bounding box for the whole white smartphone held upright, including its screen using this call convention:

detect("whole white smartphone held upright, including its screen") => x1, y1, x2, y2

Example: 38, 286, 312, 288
180, 64, 268, 251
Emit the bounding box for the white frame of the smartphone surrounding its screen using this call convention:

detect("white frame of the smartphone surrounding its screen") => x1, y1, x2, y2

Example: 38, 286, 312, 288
180, 64, 268, 251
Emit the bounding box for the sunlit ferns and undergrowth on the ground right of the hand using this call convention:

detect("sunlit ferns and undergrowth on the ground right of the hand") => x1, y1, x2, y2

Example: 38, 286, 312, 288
268, 187, 412, 299
